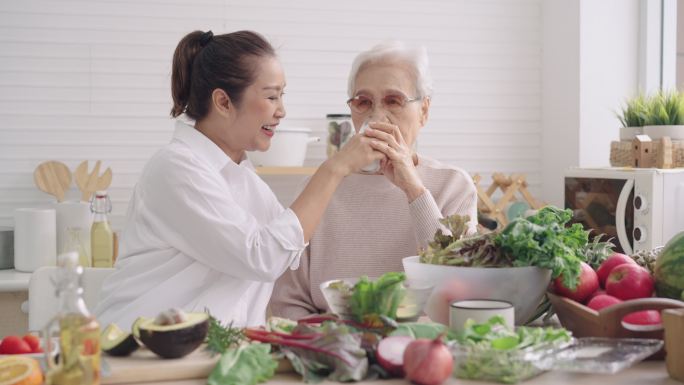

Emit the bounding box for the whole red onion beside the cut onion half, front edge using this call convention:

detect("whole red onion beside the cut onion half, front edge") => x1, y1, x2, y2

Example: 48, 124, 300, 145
404, 336, 454, 385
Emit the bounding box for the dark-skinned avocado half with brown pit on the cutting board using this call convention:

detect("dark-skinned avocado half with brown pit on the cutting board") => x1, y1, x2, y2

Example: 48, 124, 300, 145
134, 313, 209, 358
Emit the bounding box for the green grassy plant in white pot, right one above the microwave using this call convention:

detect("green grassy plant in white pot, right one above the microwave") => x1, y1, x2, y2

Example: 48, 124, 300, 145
644, 91, 684, 140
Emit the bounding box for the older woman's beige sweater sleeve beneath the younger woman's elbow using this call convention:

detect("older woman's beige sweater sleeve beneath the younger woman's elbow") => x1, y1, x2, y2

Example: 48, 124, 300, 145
269, 247, 318, 320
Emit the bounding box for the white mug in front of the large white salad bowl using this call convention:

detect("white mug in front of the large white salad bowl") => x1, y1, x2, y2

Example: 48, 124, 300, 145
449, 299, 515, 333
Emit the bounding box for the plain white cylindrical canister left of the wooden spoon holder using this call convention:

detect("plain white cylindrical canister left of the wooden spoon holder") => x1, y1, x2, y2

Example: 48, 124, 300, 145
14, 208, 57, 273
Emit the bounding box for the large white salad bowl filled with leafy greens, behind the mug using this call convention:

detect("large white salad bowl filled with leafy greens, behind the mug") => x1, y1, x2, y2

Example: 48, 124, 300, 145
402, 256, 551, 325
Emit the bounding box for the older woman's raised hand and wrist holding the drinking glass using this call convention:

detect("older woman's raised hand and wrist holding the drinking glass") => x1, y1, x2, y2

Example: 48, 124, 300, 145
365, 122, 425, 202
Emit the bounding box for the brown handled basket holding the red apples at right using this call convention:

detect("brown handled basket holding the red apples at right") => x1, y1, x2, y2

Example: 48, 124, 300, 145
546, 292, 684, 360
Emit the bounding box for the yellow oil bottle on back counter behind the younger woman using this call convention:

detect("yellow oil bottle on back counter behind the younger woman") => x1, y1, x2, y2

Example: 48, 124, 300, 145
90, 191, 114, 267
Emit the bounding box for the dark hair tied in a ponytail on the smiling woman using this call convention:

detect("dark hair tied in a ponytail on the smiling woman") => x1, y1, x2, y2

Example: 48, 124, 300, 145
171, 31, 275, 120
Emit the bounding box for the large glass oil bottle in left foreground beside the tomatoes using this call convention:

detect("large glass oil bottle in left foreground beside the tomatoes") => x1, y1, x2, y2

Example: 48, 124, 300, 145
44, 252, 100, 385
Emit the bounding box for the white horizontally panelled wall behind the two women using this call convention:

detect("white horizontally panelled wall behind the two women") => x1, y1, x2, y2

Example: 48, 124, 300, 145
0, 0, 542, 228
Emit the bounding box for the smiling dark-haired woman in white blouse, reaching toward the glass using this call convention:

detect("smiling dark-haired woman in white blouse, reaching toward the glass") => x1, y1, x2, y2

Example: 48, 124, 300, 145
96, 31, 387, 329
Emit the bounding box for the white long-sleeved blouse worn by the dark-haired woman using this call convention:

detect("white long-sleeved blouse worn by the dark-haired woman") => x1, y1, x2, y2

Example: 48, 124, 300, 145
96, 120, 306, 330
